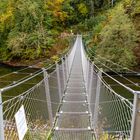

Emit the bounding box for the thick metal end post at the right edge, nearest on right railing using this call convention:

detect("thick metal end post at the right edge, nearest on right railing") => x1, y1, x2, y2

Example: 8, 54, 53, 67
130, 91, 140, 140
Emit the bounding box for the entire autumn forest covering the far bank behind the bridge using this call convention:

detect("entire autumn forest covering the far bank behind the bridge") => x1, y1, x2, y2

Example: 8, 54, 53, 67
0, 0, 140, 69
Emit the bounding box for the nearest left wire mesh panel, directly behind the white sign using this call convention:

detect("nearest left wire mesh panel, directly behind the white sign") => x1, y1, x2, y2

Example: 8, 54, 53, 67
2, 81, 50, 140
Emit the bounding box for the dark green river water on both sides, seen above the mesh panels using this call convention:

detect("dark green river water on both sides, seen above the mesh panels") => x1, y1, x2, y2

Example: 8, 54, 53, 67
0, 65, 140, 100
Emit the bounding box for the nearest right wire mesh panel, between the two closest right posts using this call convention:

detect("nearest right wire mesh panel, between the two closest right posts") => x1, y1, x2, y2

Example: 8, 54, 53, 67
96, 77, 133, 139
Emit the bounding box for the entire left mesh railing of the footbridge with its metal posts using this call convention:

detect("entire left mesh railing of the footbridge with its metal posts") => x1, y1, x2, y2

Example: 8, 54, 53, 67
0, 58, 67, 140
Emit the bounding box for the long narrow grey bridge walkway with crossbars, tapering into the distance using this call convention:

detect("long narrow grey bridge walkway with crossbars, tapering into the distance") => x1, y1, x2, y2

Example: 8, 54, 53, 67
52, 37, 93, 140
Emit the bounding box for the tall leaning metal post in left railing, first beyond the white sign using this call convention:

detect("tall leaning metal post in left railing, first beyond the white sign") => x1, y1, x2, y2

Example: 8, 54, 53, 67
43, 68, 53, 127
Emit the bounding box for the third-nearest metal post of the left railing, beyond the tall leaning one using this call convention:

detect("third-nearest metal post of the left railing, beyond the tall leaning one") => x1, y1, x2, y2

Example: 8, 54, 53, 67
56, 63, 62, 101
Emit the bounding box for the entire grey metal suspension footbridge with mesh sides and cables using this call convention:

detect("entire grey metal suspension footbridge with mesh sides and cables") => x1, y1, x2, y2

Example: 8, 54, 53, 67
0, 35, 140, 140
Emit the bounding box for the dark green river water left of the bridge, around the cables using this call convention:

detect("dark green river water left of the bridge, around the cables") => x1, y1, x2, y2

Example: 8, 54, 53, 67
0, 65, 43, 101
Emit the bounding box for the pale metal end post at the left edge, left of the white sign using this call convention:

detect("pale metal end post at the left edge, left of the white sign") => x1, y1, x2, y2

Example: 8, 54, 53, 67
0, 89, 4, 140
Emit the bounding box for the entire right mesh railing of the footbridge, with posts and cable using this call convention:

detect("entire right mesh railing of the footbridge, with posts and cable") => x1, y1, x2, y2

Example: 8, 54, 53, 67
82, 34, 139, 140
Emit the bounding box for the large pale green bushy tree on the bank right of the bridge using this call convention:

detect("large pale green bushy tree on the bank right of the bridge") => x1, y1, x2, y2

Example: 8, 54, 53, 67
97, 5, 137, 67
